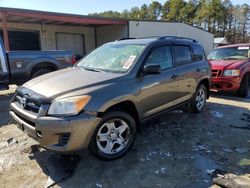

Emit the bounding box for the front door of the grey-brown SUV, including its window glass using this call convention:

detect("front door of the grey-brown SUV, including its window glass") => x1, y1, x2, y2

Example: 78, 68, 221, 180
139, 45, 178, 118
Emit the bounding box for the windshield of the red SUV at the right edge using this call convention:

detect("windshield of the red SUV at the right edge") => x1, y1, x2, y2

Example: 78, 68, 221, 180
207, 47, 250, 60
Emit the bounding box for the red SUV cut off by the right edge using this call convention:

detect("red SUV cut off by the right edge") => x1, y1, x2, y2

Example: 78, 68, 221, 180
208, 43, 250, 97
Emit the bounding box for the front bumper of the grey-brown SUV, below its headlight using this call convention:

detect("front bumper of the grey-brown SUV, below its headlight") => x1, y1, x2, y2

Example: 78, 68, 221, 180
10, 102, 100, 152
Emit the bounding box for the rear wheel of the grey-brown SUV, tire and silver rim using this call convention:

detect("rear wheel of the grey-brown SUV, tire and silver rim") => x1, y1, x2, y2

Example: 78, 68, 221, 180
189, 84, 208, 113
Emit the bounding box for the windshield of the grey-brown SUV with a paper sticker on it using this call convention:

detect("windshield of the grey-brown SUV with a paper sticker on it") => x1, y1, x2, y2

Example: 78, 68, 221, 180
77, 43, 145, 73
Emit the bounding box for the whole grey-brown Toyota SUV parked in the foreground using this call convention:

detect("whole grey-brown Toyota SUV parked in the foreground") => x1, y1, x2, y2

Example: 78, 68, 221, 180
10, 37, 211, 160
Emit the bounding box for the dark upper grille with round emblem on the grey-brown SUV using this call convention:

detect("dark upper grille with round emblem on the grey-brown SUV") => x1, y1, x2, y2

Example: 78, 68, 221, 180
15, 95, 41, 114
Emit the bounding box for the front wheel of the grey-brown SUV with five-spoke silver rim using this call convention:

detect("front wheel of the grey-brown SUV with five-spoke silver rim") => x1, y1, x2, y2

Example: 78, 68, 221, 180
89, 111, 136, 161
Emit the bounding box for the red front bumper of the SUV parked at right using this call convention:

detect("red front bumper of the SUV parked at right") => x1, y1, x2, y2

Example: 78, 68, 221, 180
211, 77, 241, 91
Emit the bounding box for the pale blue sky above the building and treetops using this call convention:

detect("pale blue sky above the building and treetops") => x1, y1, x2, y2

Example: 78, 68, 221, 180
0, 0, 250, 15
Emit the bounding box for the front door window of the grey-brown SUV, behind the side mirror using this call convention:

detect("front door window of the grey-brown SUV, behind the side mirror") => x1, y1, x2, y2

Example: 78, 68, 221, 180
146, 46, 173, 70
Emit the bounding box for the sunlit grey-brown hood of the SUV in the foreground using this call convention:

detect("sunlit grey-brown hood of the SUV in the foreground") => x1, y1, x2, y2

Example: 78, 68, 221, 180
22, 67, 122, 98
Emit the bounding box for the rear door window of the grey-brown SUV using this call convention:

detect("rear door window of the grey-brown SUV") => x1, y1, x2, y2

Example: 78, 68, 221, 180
174, 46, 192, 66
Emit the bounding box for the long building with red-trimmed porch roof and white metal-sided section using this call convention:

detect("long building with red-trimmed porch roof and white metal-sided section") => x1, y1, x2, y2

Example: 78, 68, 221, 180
0, 8, 214, 56
